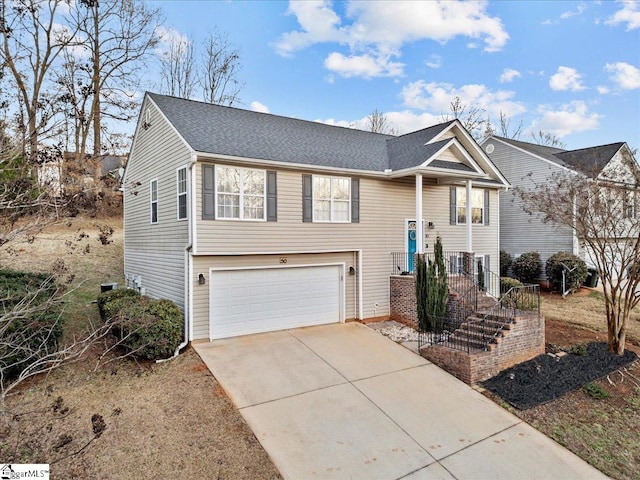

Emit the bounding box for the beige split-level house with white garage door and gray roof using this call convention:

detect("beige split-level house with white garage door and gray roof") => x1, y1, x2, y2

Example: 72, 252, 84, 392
123, 93, 508, 341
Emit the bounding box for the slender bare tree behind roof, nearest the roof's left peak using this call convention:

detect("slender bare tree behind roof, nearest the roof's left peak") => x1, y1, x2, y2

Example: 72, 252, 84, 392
160, 34, 196, 98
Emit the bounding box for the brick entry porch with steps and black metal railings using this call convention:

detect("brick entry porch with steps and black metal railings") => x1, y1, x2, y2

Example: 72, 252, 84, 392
389, 252, 545, 384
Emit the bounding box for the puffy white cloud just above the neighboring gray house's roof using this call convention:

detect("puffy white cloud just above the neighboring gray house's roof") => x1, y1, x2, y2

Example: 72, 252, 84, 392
529, 101, 602, 137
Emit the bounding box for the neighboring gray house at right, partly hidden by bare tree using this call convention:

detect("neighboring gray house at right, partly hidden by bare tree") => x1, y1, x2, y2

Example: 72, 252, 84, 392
480, 135, 640, 275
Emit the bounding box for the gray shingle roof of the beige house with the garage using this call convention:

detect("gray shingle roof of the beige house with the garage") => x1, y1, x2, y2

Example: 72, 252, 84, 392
147, 93, 478, 172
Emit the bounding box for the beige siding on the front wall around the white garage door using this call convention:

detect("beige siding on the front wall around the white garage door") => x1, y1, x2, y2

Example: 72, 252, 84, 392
194, 162, 499, 338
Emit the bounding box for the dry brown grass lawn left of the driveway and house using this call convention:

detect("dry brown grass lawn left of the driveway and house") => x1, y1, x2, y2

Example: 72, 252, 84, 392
0, 220, 281, 479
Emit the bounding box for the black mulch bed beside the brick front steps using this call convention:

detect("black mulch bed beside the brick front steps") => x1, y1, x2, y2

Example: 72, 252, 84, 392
482, 342, 638, 410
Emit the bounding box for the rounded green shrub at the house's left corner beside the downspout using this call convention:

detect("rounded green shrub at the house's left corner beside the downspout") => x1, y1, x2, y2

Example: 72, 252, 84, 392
112, 297, 183, 360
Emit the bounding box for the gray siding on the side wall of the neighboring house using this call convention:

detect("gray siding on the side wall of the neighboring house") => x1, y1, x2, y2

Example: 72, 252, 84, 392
483, 139, 573, 275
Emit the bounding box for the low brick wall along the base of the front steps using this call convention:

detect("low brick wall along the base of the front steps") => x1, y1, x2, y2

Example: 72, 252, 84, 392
420, 315, 545, 385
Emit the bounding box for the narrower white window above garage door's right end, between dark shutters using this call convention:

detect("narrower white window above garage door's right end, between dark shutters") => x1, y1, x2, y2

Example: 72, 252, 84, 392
313, 175, 351, 222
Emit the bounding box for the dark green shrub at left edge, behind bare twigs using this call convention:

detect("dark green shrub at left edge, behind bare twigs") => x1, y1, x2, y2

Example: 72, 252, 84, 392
0, 270, 63, 382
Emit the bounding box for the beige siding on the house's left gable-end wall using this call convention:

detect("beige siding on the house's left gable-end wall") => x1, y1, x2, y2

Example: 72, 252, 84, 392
123, 99, 191, 309
